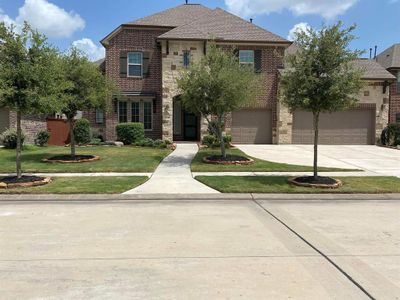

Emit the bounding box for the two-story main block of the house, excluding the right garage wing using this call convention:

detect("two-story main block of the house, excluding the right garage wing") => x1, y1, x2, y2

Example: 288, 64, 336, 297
97, 4, 291, 143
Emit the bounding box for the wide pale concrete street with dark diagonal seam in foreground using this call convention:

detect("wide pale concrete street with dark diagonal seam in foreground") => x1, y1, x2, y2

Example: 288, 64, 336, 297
0, 198, 400, 300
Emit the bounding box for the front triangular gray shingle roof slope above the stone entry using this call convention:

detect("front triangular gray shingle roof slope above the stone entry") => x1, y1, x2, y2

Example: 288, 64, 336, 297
159, 8, 290, 43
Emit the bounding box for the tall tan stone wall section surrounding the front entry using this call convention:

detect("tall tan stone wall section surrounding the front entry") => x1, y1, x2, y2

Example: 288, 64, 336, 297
162, 41, 204, 140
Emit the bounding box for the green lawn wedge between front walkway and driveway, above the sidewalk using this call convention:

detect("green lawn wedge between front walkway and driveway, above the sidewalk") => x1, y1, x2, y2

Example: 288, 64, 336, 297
192, 149, 360, 172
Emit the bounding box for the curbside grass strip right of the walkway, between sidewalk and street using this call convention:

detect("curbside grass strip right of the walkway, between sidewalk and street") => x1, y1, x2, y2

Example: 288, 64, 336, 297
196, 176, 400, 194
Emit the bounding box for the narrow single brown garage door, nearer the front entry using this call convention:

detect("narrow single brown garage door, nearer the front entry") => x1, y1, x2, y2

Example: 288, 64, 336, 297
232, 109, 272, 144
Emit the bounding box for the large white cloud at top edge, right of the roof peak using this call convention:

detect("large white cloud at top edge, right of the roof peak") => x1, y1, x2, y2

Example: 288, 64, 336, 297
225, 0, 359, 19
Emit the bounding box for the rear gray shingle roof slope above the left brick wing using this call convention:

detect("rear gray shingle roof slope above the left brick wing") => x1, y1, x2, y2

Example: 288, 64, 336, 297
127, 4, 212, 27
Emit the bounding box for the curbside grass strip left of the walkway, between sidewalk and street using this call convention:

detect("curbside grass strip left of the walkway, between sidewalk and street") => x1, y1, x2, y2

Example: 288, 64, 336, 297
0, 176, 148, 195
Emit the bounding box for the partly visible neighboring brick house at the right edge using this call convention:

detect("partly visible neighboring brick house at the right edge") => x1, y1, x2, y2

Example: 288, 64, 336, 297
377, 44, 400, 123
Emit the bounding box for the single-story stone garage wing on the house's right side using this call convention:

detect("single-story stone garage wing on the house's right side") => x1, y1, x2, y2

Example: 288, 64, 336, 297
276, 44, 395, 145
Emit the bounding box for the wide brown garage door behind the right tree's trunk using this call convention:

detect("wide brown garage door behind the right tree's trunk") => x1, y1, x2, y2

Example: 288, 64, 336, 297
292, 109, 375, 145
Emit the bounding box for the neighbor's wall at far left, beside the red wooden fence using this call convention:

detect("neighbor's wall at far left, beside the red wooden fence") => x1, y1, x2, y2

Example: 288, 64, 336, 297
10, 112, 47, 144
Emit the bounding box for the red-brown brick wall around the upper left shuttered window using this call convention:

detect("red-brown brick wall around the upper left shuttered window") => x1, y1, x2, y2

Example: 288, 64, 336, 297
104, 29, 166, 140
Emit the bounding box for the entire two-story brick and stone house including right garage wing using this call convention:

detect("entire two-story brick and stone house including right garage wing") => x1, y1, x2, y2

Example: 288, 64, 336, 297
93, 4, 395, 144
